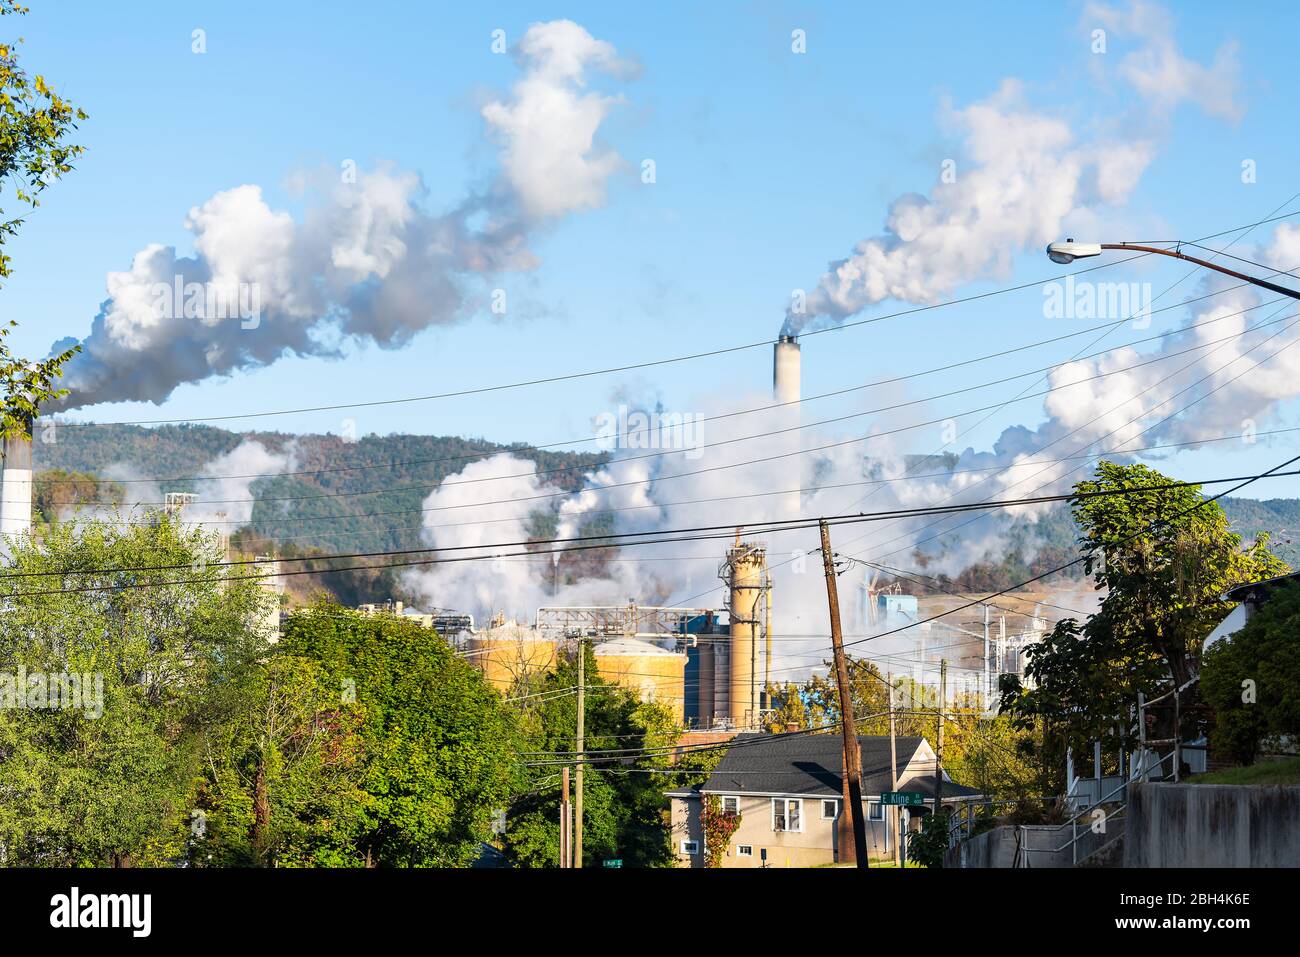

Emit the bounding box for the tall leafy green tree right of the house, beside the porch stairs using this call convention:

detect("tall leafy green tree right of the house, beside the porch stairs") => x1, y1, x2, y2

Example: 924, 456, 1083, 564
1001, 462, 1286, 780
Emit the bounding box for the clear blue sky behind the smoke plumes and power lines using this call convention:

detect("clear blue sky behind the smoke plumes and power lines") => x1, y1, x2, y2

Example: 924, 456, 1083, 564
0, 0, 1300, 497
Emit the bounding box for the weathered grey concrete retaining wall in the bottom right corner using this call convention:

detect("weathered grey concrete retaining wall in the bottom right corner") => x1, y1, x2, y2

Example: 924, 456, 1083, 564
1125, 784, 1300, 867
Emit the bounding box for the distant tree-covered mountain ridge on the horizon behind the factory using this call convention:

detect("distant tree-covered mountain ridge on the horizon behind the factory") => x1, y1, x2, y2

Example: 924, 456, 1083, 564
33, 425, 1300, 579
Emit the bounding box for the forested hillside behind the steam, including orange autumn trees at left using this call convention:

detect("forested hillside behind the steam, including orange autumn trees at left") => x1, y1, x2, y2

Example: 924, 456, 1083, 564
33, 425, 1300, 601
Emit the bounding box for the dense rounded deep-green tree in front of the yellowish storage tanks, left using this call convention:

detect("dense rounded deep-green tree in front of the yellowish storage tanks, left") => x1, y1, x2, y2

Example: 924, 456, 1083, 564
280, 602, 517, 867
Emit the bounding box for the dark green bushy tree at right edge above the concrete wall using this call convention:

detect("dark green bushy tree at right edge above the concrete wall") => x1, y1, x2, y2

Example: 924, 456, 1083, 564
1200, 581, 1300, 765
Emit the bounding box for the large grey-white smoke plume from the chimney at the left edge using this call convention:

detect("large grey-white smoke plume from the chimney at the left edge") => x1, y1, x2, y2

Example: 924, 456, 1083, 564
52, 21, 632, 408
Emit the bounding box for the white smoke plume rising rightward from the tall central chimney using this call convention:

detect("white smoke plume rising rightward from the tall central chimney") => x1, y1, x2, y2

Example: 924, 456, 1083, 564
783, 0, 1243, 333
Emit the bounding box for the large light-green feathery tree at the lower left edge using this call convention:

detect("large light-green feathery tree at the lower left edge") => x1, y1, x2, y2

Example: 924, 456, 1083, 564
0, 514, 267, 866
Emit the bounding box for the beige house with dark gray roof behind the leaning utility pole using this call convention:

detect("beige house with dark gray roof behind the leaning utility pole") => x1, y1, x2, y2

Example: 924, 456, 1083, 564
668, 733, 976, 867
